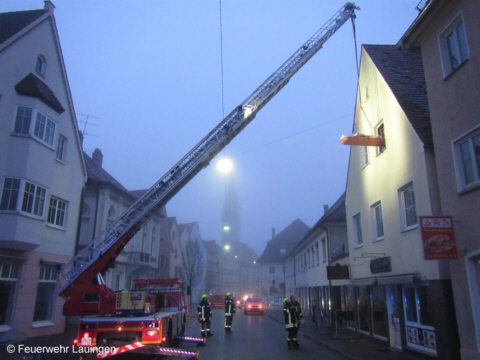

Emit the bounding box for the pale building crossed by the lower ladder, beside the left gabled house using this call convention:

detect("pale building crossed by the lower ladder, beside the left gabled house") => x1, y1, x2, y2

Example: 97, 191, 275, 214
78, 149, 172, 291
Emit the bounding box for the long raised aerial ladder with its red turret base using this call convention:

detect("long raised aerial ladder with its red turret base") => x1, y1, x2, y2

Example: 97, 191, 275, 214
58, 2, 359, 316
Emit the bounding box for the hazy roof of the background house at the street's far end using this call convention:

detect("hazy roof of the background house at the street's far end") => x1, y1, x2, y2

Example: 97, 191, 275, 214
257, 219, 310, 263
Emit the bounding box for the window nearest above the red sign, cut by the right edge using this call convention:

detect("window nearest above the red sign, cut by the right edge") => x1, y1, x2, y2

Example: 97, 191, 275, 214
454, 129, 480, 190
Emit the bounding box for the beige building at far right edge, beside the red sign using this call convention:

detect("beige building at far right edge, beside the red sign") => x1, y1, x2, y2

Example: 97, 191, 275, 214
401, 0, 480, 360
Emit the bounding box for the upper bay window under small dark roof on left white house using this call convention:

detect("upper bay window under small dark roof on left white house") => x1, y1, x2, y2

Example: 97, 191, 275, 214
13, 106, 57, 148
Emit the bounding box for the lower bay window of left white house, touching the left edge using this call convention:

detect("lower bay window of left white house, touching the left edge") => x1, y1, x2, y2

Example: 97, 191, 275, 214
0, 178, 47, 216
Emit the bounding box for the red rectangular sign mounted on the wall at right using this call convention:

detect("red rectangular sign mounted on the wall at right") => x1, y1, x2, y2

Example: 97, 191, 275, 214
420, 216, 458, 260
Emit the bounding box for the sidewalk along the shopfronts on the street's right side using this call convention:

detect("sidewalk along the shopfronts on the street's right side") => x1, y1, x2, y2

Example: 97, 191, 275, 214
265, 308, 432, 360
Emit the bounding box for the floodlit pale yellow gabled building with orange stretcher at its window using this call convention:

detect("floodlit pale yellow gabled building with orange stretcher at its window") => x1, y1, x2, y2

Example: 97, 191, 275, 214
341, 45, 458, 359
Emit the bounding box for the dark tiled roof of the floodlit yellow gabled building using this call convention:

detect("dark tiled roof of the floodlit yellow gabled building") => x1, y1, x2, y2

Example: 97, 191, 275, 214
363, 45, 433, 148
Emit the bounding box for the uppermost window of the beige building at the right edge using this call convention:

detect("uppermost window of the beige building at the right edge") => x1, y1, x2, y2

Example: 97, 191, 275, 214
438, 12, 470, 79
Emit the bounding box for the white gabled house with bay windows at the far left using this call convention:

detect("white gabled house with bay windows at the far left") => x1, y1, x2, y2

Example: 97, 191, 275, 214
0, 1, 86, 337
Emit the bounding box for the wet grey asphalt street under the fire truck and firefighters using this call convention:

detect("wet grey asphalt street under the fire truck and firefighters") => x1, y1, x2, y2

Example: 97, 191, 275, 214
0, 308, 345, 360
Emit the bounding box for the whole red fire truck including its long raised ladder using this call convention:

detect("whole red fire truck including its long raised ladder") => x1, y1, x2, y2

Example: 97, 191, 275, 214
58, 2, 359, 358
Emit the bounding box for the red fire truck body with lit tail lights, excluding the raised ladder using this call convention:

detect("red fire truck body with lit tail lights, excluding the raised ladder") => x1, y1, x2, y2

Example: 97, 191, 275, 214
74, 279, 188, 348
